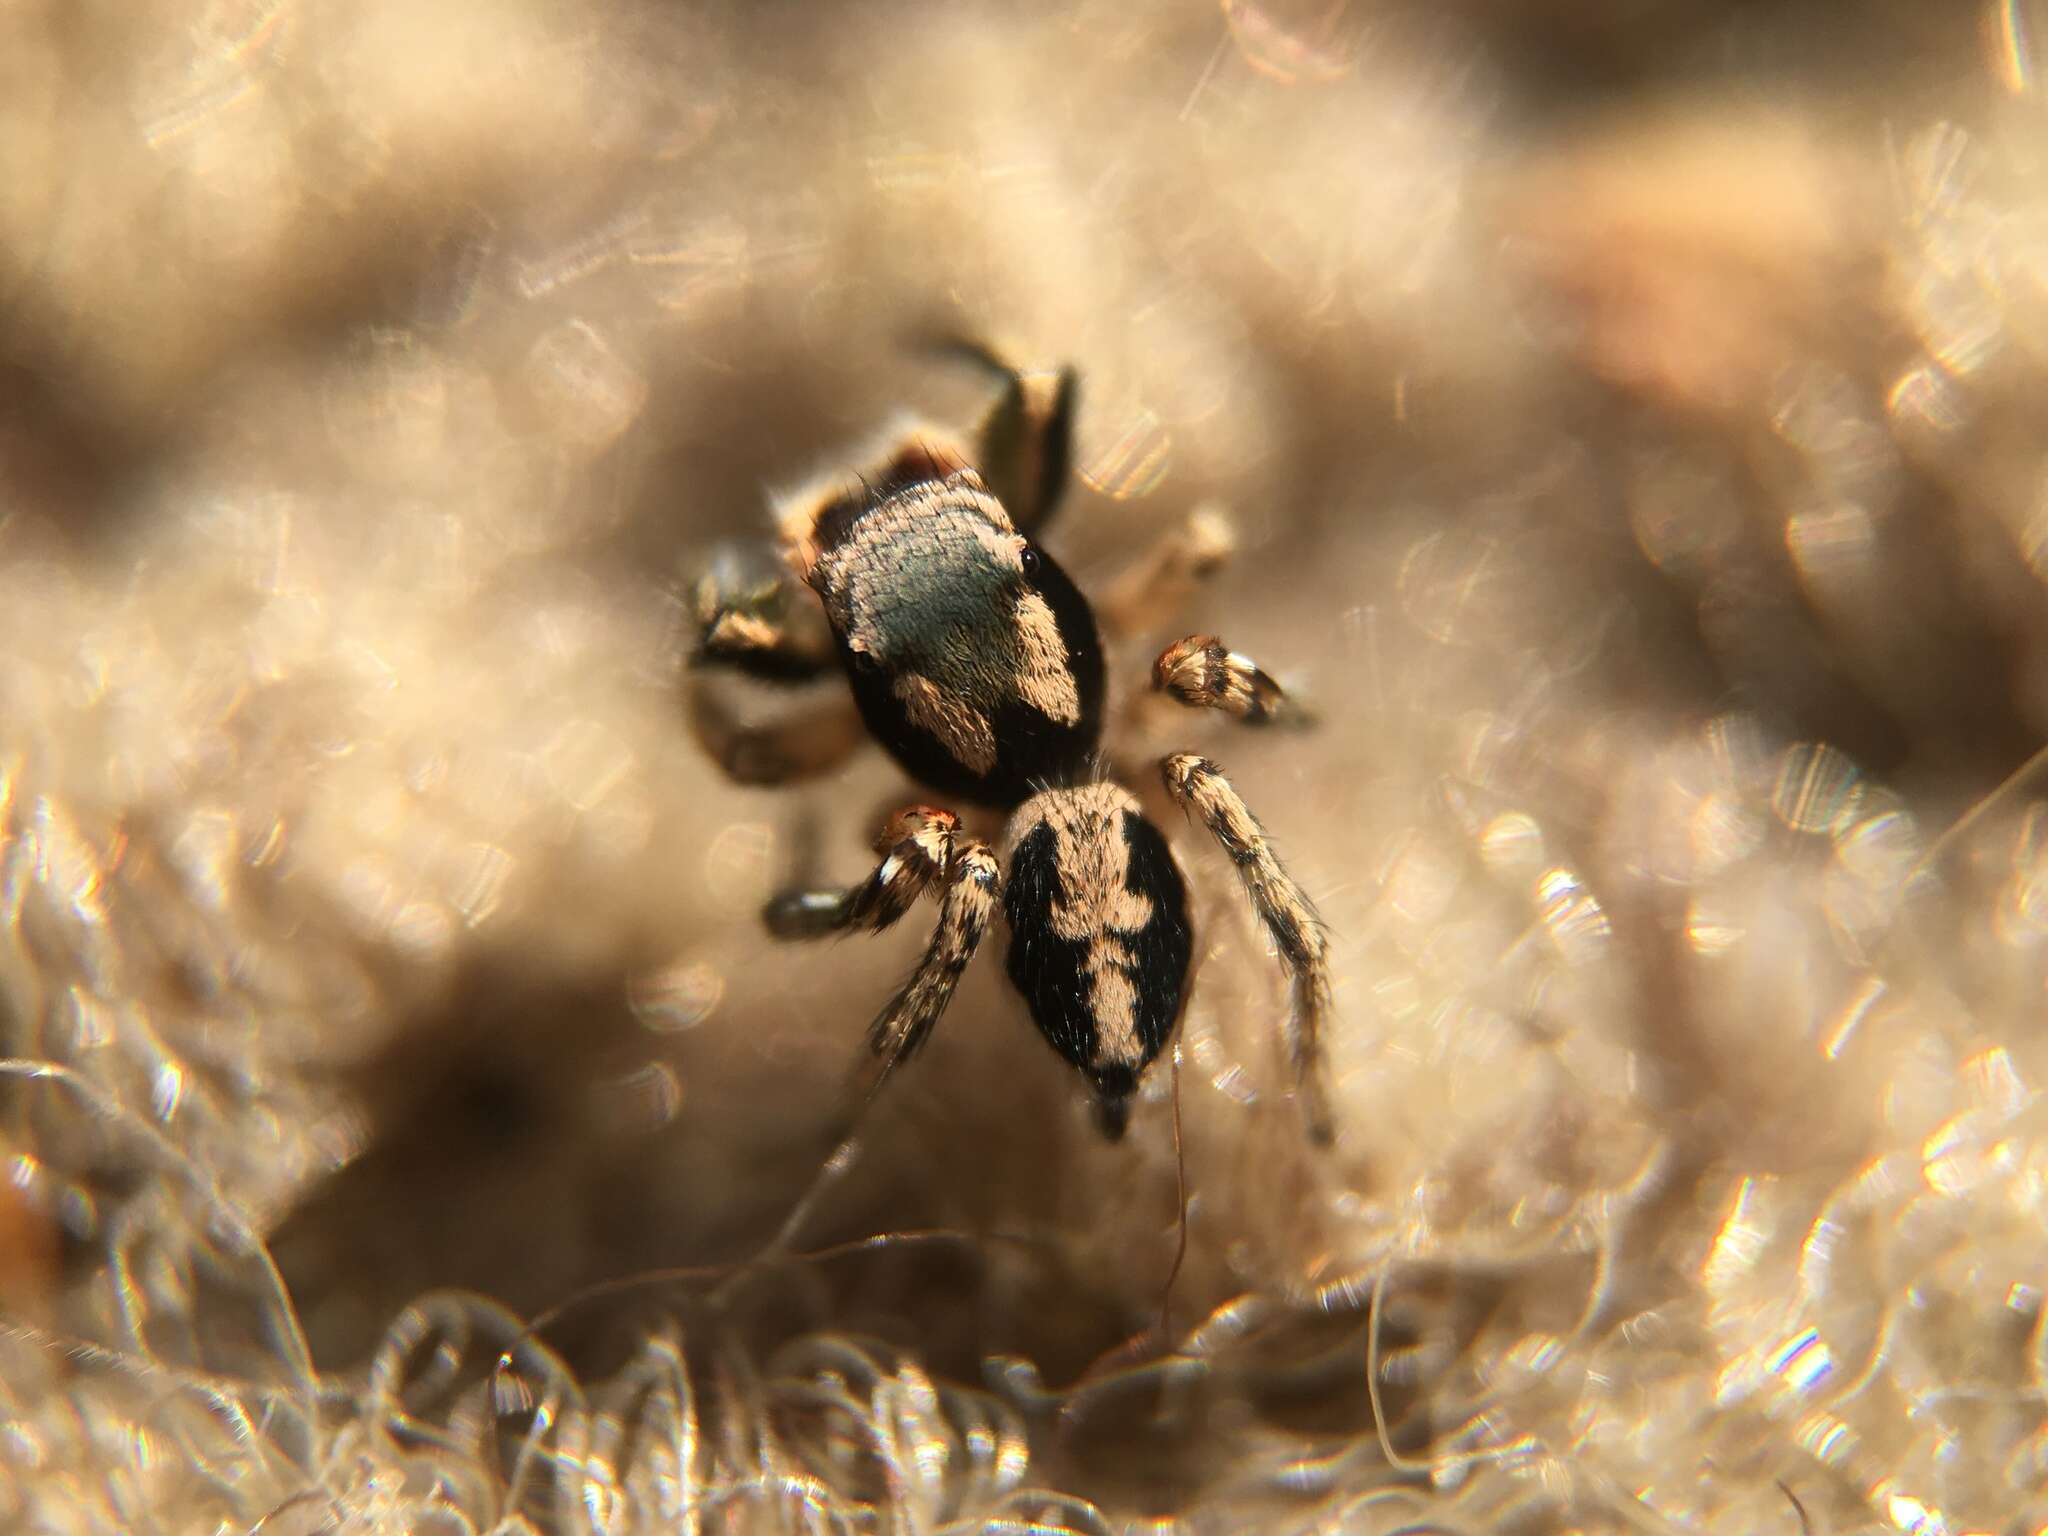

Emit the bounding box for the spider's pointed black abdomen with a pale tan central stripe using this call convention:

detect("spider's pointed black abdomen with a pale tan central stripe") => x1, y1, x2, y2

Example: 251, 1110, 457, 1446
1004, 782, 1192, 1137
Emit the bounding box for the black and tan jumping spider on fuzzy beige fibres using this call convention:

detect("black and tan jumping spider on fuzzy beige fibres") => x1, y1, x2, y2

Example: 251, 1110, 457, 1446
692, 348, 1329, 1141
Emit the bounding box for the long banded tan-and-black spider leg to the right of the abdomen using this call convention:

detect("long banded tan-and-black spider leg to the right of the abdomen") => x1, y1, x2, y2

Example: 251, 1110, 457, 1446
1159, 752, 1331, 1143
